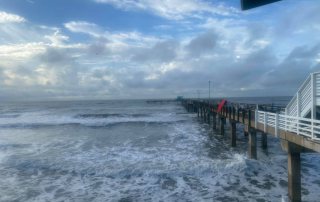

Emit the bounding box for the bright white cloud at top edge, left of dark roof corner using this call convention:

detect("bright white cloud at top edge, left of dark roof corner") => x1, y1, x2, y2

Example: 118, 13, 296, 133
95, 0, 238, 20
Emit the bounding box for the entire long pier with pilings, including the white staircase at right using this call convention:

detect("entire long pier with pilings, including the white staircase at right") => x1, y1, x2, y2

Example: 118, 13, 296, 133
181, 72, 320, 202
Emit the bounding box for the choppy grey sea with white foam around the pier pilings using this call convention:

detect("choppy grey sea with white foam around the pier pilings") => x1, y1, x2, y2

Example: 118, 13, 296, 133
0, 98, 320, 202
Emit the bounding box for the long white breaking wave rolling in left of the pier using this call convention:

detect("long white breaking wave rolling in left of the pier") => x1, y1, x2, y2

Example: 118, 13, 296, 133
0, 113, 185, 128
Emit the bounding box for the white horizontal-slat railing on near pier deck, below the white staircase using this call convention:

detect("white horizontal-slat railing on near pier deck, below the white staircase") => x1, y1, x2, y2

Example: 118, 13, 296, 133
255, 110, 320, 140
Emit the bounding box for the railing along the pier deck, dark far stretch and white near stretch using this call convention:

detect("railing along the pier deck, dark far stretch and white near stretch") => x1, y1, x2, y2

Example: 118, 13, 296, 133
182, 100, 320, 141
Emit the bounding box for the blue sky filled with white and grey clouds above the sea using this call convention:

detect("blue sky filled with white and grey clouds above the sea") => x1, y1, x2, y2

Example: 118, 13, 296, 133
0, 0, 320, 100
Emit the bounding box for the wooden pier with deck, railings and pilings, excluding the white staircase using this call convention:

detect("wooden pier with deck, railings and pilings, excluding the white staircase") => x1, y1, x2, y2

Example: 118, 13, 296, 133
181, 99, 320, 202
